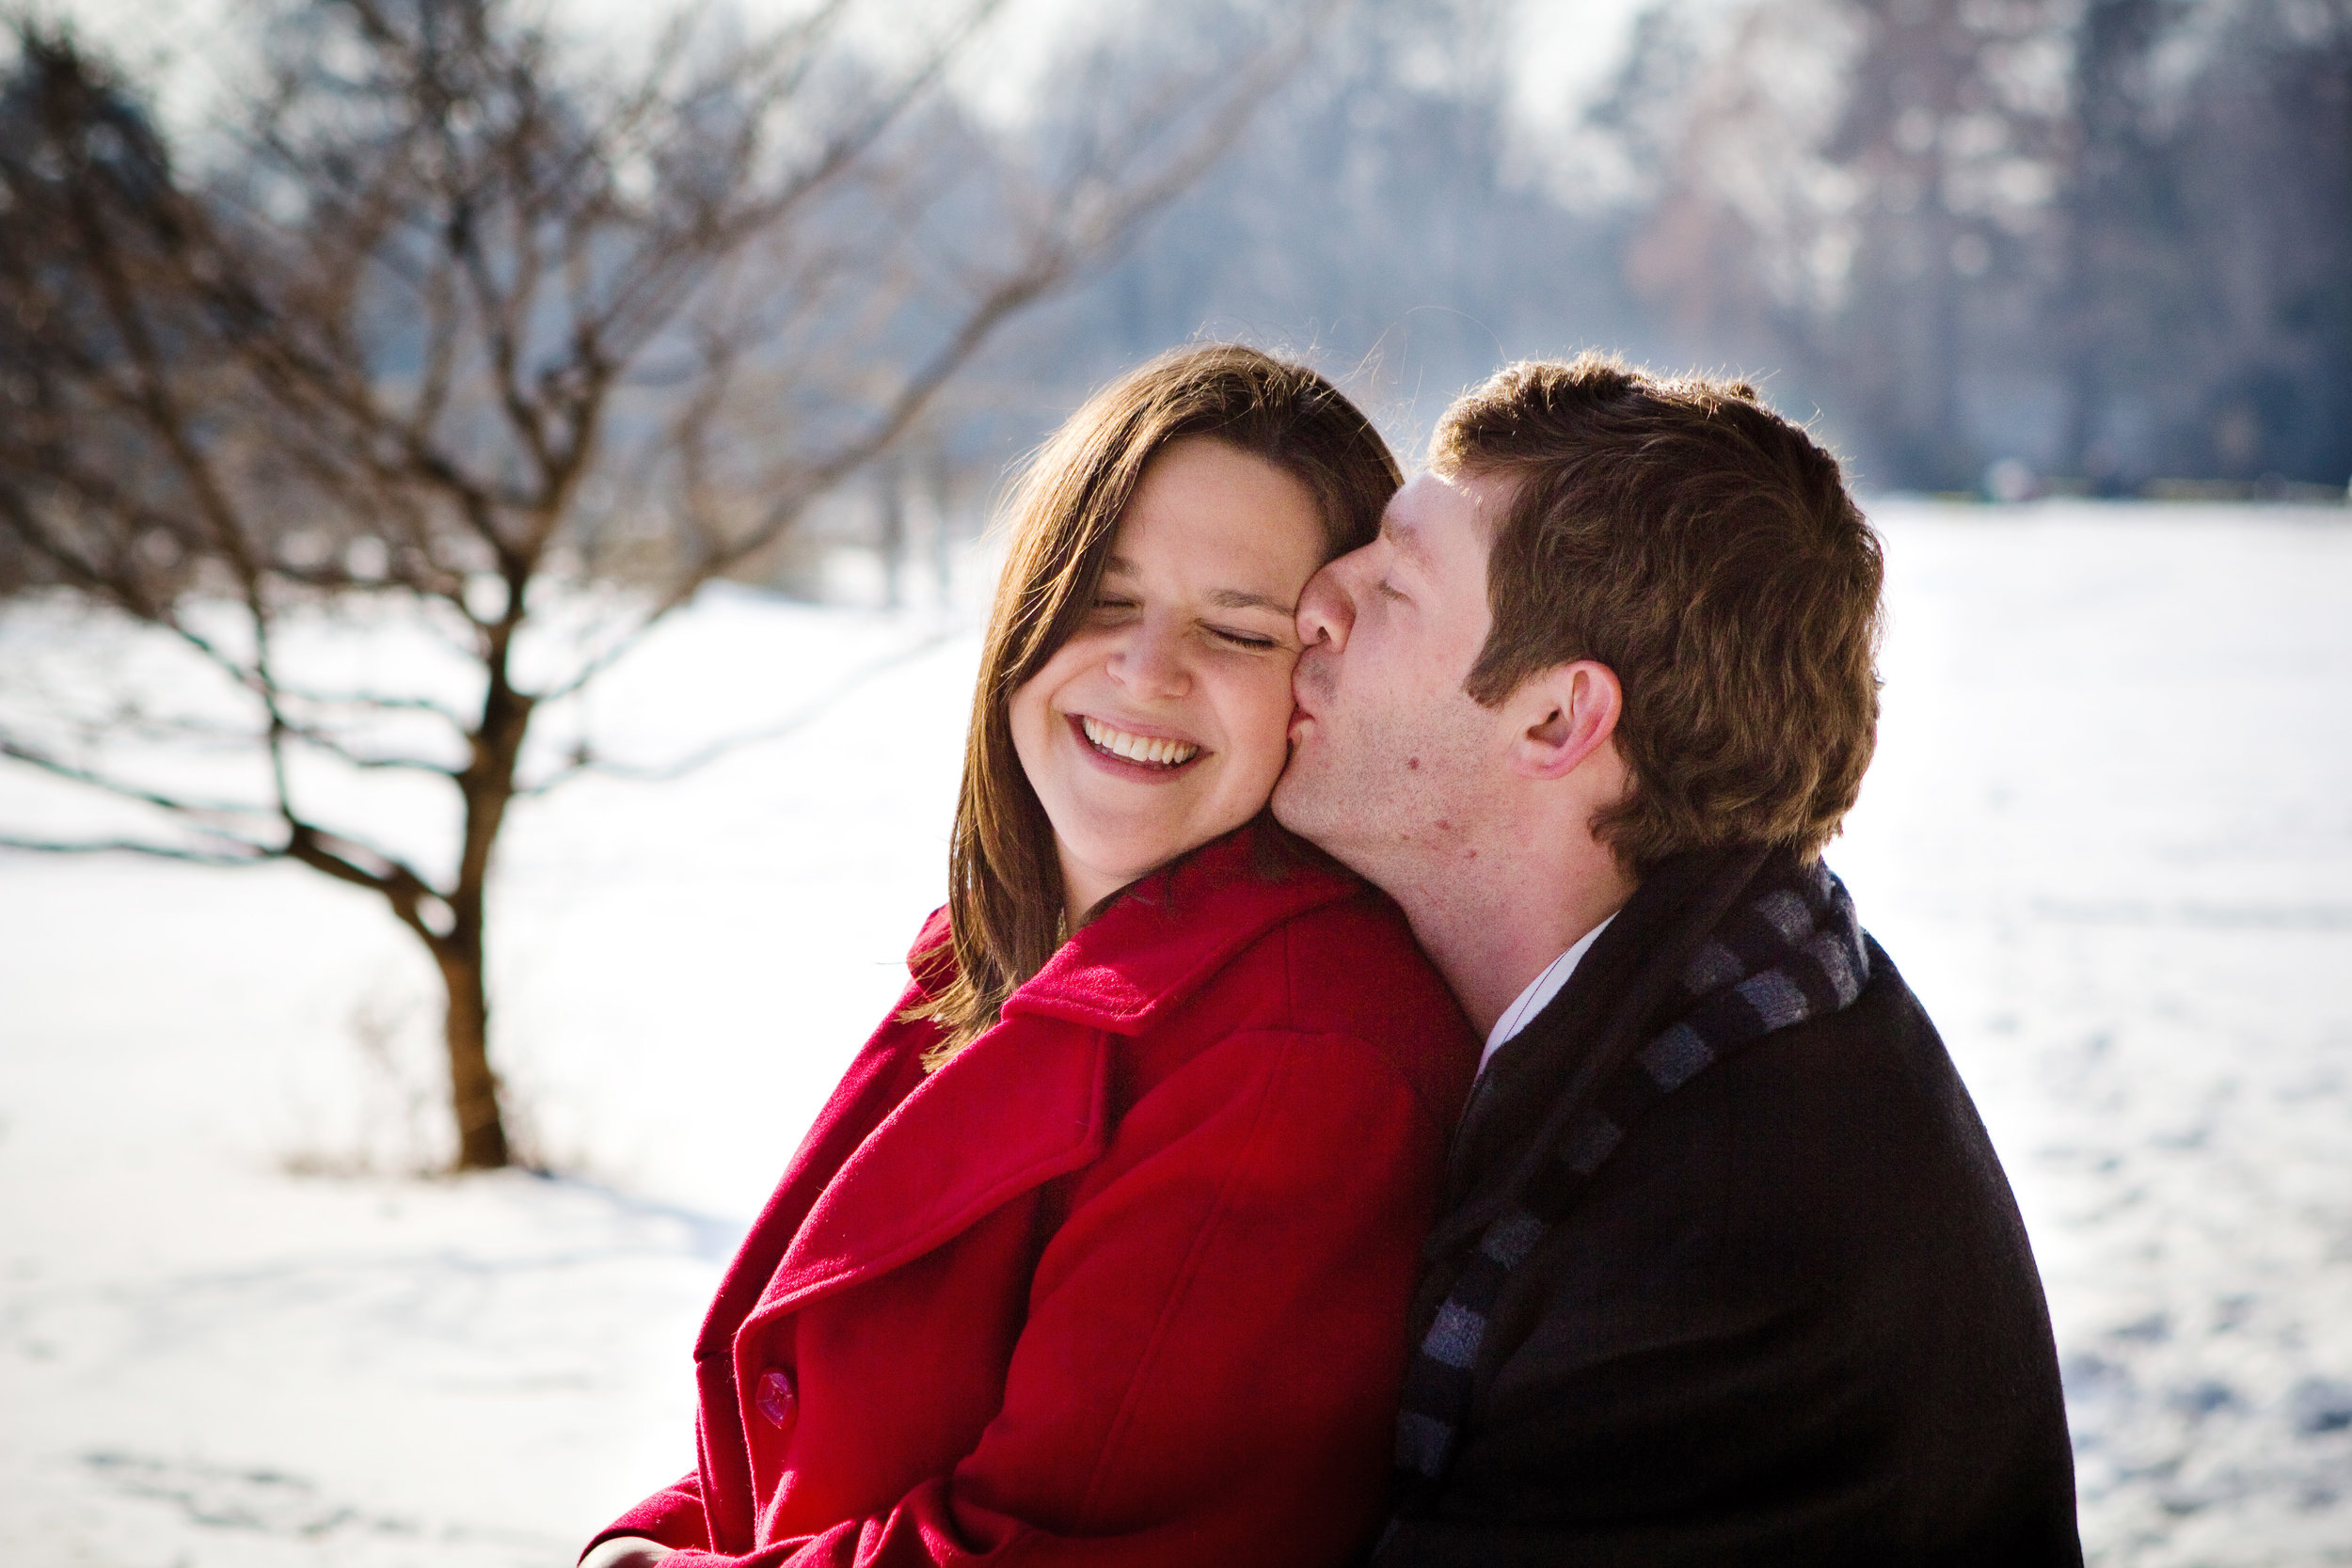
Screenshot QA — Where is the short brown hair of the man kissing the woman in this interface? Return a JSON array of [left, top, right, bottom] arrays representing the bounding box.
[[1430, 355, 1884, 870]]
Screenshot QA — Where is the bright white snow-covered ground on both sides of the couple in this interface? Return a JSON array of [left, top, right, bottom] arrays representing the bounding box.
[[0, 503, 2352, 1568]]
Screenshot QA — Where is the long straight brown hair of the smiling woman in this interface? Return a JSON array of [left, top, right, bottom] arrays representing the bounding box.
[[911, 343, 1402, 1068]]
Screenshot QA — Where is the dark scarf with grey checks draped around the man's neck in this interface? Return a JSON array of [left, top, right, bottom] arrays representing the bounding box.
[[1397, 853, 1870, 1502]]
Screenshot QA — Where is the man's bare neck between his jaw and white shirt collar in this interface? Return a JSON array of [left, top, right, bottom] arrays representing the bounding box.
[[1388, 842, 1637, 1035]]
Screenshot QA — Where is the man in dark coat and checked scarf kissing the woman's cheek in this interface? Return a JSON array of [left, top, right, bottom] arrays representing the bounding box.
[[1275, 355, 2082, 1568]]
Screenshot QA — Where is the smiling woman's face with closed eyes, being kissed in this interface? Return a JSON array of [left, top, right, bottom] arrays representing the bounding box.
[[1009, 435, 1325, 914]]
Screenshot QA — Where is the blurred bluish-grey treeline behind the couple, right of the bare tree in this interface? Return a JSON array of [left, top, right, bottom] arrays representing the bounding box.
[[991, 0, 2352, 499]]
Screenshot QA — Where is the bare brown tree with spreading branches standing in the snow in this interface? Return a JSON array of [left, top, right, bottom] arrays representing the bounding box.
[[0, 0, 1331, 1168]]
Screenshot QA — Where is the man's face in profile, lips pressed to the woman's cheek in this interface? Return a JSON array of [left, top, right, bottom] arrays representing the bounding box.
[[1275, 465, 1510, 891]]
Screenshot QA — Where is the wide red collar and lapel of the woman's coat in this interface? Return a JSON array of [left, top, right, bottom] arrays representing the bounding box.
[[734, 828, 1358, 1350]]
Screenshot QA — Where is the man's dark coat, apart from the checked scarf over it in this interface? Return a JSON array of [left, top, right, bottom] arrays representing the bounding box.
[[1376, 853, 2082, 1568]]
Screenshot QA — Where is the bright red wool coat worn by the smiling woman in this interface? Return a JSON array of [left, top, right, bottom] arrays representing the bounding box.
[[597, 830, 1477, 1568]]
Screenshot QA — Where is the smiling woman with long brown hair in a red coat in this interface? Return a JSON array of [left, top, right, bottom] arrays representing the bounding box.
[[583, 345, 1477, 1568]]
